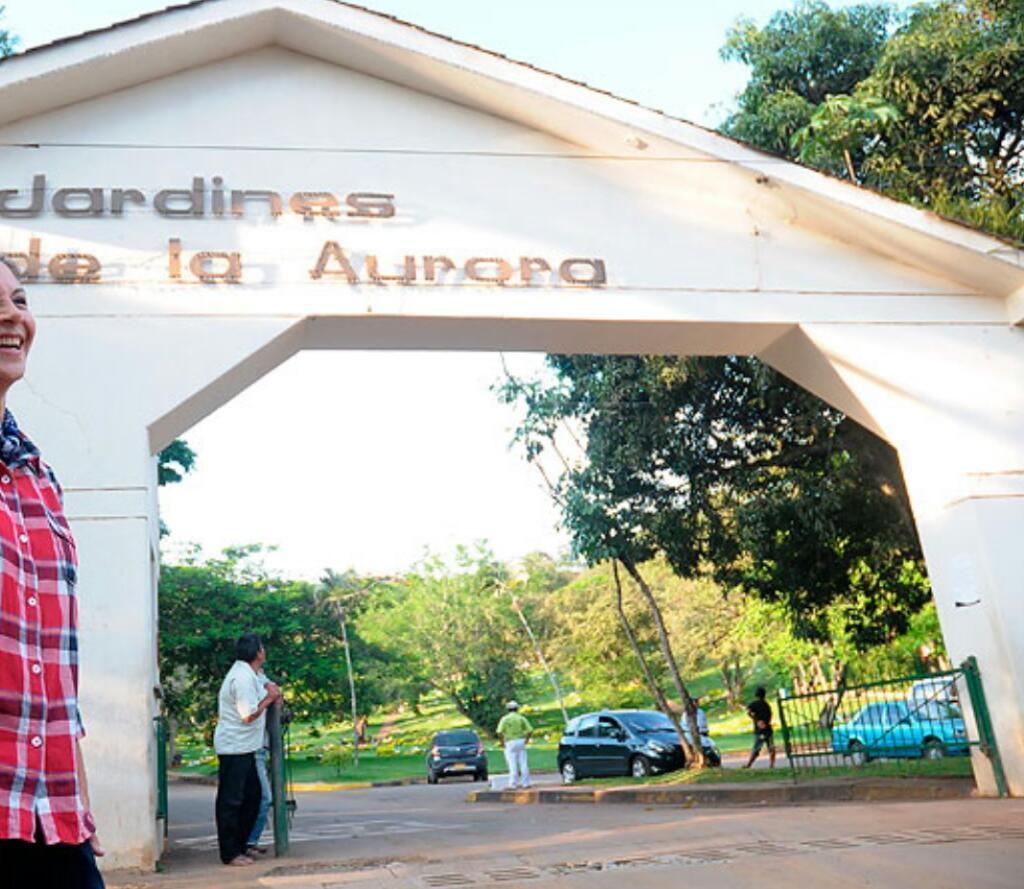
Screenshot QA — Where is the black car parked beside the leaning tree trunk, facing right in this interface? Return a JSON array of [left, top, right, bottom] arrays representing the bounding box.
[[558, 710, 721, 784]]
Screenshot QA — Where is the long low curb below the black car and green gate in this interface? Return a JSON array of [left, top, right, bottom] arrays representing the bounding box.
[[466, 778, 975, 808]]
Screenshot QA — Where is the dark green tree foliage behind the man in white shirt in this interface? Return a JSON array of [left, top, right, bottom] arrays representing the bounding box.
[[160, 547, 385, 731]]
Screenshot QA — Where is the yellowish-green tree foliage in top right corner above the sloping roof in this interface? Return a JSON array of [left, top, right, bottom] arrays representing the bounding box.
[[858, 0, 1024, 241]]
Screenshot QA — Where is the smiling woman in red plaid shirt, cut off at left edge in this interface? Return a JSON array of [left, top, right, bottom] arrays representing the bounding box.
[[0, 255, 103, 889]]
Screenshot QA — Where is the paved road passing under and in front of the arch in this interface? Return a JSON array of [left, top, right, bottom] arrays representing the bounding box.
[[111, 781, 1024, 889]]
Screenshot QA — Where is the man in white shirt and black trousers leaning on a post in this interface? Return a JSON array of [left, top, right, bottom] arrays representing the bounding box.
[[213, 633, 281, 867]]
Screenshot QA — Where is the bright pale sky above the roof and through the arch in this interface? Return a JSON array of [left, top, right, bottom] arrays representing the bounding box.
[[0, 0, 907, 578]]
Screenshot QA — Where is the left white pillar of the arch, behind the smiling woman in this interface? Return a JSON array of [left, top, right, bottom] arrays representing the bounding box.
[[10, 316, 303, 870]]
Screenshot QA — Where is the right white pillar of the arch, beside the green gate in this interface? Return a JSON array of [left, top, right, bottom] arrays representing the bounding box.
[[790, 325, 1024, 796]]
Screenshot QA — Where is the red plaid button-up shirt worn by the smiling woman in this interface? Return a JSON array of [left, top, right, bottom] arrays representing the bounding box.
[[0, 413, 95, 844]]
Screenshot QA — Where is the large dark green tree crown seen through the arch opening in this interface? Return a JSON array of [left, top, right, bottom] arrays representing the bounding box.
[[499, 355, 929, 646]]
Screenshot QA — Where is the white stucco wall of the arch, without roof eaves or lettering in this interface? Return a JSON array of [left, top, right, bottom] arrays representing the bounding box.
[[0, 39, 1024, 866]]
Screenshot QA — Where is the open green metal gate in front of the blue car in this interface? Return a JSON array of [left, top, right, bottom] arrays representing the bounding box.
[[778, 658, 1007, 797]]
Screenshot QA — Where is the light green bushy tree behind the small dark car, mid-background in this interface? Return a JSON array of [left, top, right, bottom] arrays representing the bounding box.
[[356, 547, 529, 734]]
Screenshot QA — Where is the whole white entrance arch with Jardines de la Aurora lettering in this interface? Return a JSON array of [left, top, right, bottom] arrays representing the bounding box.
[[0, 0, 1024, 866]]
